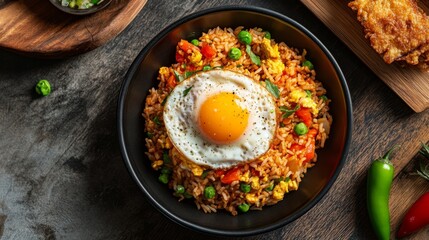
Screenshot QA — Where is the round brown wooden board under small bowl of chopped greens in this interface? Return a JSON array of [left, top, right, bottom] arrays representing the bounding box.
[[0, 0, 147, 58]]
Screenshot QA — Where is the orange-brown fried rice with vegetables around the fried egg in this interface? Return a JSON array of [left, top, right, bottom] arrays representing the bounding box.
[[142, 27, 332, 215]]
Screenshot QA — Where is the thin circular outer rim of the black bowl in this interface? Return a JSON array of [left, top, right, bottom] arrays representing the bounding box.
[[117, 5, 353, 237]]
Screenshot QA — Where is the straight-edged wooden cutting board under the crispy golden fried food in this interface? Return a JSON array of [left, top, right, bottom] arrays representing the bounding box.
[[301, 0, 429, 112]]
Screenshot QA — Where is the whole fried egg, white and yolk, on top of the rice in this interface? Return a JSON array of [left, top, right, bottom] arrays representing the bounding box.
[[163, 70, 277, 169]]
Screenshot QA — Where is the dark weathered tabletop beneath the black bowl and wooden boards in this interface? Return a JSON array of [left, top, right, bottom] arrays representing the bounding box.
[[0, 0, 429, 240]]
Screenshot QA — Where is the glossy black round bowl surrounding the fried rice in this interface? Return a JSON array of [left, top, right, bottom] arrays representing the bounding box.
[[118, 6, 352, 236]]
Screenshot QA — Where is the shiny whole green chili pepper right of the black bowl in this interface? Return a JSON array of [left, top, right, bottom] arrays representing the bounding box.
[[367, 147, 395, 240]]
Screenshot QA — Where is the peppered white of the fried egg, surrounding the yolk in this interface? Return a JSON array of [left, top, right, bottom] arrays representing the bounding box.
[[163, 70, 277, 169]]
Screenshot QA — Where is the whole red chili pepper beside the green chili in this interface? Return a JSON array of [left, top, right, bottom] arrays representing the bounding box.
[[396, 192, 429, 238]]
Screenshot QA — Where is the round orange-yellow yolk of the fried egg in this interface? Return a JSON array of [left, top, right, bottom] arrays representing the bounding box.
[[198, 92, 249, 144]]
